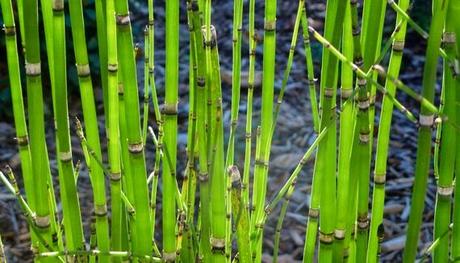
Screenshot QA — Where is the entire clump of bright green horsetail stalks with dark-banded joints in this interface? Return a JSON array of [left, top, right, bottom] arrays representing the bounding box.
[[0, 0, 460, 263]]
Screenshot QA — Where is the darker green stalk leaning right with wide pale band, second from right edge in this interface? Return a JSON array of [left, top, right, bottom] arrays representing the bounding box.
[[403, 0, 449, 262]]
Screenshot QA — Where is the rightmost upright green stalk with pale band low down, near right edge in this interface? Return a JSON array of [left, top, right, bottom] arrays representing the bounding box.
[[433, 4, 458, 262]]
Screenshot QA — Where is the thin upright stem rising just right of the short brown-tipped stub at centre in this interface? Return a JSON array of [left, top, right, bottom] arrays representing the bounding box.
[[242, 0, 257, 223]]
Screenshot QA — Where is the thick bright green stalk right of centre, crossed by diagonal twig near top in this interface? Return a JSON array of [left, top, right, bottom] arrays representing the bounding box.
[[310, 0, 347, 262]]
